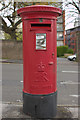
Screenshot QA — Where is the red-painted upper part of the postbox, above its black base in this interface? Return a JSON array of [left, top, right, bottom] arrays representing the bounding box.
[[17, 6, 61, 94]]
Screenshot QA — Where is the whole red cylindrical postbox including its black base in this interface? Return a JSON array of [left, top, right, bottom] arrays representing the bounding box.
[[17, 5, 61, 118]]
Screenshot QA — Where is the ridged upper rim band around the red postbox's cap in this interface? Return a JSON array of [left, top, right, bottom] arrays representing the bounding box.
[[17, 5, 62, 16]]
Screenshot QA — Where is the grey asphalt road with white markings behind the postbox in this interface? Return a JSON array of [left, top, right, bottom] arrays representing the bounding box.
[[2, 58, 80, 106]]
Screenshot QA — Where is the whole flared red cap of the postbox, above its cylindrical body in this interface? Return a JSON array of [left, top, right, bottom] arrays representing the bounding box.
[[17, 5, 62, 19]]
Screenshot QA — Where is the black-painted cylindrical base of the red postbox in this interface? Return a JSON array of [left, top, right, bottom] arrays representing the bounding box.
[[23, 92, 57, 119]]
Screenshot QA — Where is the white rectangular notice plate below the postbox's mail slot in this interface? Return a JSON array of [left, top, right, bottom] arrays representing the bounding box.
[[36, 33, 46, 50]]
